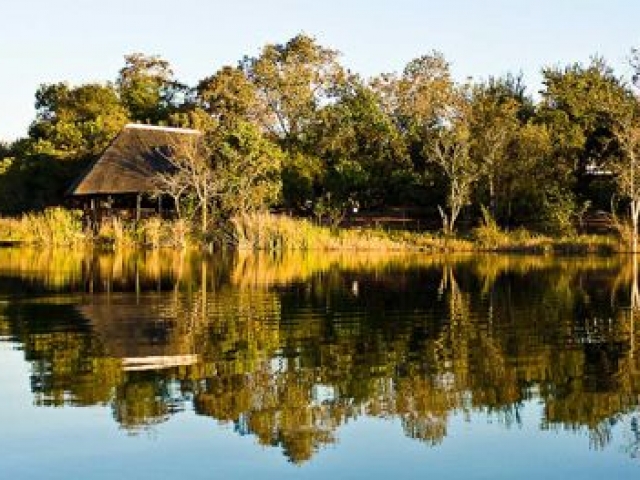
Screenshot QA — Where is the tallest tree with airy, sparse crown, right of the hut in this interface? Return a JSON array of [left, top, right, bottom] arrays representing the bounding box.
[[240, 34, 345, 209]]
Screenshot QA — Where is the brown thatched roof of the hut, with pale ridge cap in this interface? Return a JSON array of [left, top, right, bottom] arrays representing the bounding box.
[[69, 124, 199, 195]]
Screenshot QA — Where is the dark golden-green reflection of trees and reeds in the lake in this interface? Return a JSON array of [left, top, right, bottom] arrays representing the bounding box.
[[0, 249, 640, 462]]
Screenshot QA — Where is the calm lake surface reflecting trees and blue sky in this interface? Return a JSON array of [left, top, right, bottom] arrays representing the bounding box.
[[0, 248, 640, 479]]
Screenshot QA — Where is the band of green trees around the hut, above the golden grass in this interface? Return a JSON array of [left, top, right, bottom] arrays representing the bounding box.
[[0, 35, 640, 233]]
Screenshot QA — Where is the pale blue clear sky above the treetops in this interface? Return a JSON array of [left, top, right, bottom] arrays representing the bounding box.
[[0, 0, 640, 141]]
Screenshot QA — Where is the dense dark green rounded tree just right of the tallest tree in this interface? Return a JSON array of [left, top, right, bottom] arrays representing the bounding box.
[[310, 76, 409, 224]]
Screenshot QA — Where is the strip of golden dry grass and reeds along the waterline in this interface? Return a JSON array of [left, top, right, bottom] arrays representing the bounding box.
[[0, 208, 628, 254]]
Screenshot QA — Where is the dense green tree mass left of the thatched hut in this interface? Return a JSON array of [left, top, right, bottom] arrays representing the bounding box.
[[0, 83, 128, 214]]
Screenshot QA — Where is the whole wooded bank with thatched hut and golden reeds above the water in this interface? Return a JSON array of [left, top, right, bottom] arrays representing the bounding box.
[[0, 35, 640, 253]]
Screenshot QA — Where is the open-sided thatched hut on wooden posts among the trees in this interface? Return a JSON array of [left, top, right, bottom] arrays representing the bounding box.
[[68, 124, 199, 223]]
